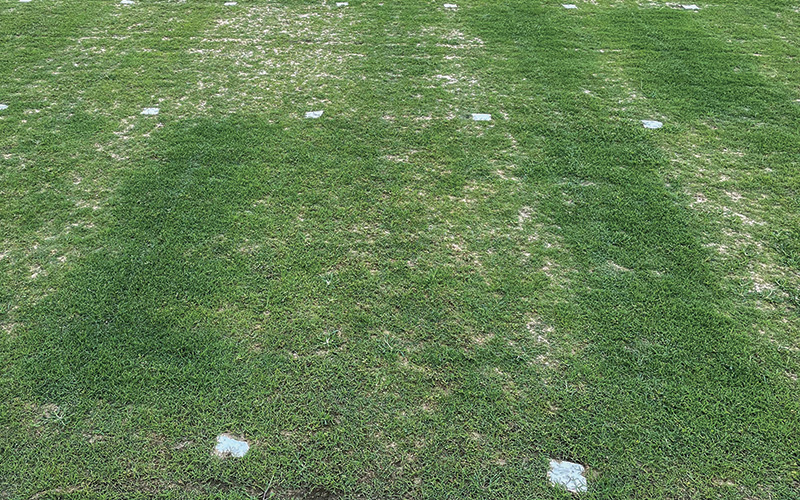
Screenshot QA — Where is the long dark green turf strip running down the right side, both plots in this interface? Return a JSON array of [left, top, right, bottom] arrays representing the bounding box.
[[462, 0, 798, 498]]
